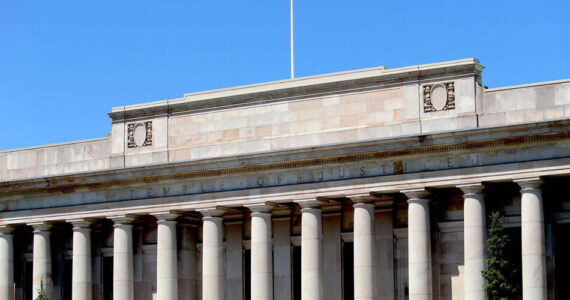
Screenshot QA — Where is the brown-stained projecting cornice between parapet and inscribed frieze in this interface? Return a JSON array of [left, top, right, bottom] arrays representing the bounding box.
[[0, 120, 570, 196]]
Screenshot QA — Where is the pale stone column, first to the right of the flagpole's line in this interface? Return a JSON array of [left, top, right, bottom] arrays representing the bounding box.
[[300, 201, 325, 300]]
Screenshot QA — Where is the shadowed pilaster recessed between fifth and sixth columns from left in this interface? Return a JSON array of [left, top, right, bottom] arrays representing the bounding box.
[[178, 221, 198, 300]]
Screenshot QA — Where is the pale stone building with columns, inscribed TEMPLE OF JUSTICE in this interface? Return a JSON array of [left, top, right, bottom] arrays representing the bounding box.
[[0, 59, 570, 300]]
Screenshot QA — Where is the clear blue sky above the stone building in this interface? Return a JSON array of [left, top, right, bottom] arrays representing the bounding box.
[[0, 0, 570, 150]]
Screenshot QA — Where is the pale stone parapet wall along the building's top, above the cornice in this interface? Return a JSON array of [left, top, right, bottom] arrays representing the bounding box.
[[0, 59, 570, 181]]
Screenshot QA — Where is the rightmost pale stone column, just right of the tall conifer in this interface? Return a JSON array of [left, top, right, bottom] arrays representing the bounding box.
[[517, 178, 546, 300]]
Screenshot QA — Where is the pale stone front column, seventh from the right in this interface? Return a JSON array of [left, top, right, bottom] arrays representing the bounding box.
[[201, 209, 225, 300]]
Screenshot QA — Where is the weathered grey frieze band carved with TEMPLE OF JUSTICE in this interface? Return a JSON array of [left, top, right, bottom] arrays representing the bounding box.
[[2, 132, 570, 201]]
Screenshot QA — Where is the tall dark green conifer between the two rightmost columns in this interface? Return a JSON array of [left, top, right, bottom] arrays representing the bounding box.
[[481, 212, 518, 300]]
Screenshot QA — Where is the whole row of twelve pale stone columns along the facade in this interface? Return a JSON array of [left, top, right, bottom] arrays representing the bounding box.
[[0, 179, 546, 300]]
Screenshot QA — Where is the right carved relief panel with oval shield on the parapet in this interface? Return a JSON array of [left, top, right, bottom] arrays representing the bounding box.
[[424, 81, 455, 113]]
